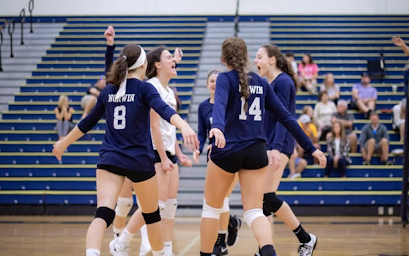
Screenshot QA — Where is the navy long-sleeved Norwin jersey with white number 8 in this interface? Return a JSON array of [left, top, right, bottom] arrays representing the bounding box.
[[78, 79, 176, 171]]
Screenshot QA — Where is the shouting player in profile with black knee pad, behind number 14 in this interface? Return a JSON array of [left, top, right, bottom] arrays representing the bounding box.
[[254, 45, 317, 256]]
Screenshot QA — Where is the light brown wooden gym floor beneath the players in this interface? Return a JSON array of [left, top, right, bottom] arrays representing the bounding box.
[[0, 216, 409, 256]]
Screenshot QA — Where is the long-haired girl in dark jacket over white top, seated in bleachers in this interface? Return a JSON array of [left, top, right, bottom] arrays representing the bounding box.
[[324, 122, 351, 178]]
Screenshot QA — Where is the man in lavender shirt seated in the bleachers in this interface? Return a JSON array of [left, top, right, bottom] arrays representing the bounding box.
[[351, 72, 378, 118]]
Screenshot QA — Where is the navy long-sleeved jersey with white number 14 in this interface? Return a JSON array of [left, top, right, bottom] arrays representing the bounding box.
[[211, 70, 315, 159]]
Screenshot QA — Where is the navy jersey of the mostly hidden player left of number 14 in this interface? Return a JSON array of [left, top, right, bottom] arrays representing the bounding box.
[[197, 98, 213, 153]]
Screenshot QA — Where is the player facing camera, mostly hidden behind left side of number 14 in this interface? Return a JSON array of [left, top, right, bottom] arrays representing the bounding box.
[[193, 70, 241, 256]]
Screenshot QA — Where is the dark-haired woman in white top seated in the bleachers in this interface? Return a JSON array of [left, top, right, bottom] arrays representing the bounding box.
[[314, 91, 337, 140]]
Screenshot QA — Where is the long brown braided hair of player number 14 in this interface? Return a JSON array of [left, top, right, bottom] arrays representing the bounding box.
[[221, 37, 250, 112]]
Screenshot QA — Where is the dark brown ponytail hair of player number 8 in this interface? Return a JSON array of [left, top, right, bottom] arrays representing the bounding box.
[[107, 44, 141, 86]]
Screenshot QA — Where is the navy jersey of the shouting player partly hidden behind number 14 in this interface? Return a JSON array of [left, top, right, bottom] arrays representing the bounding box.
[[265, 72, 295, 155]]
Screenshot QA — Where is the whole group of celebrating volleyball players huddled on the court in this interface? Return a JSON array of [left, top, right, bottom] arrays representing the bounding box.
[[53, 27, 326, 256]]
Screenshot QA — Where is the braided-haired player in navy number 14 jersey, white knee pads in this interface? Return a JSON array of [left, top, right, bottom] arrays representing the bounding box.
[[200, 38, 326, 256]]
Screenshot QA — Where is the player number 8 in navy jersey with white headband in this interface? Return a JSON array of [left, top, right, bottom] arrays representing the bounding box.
[[53, 45, 199, 256]]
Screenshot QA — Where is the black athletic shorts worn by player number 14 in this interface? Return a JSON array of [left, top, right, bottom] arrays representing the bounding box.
[[212, 141, 268, 173]]
